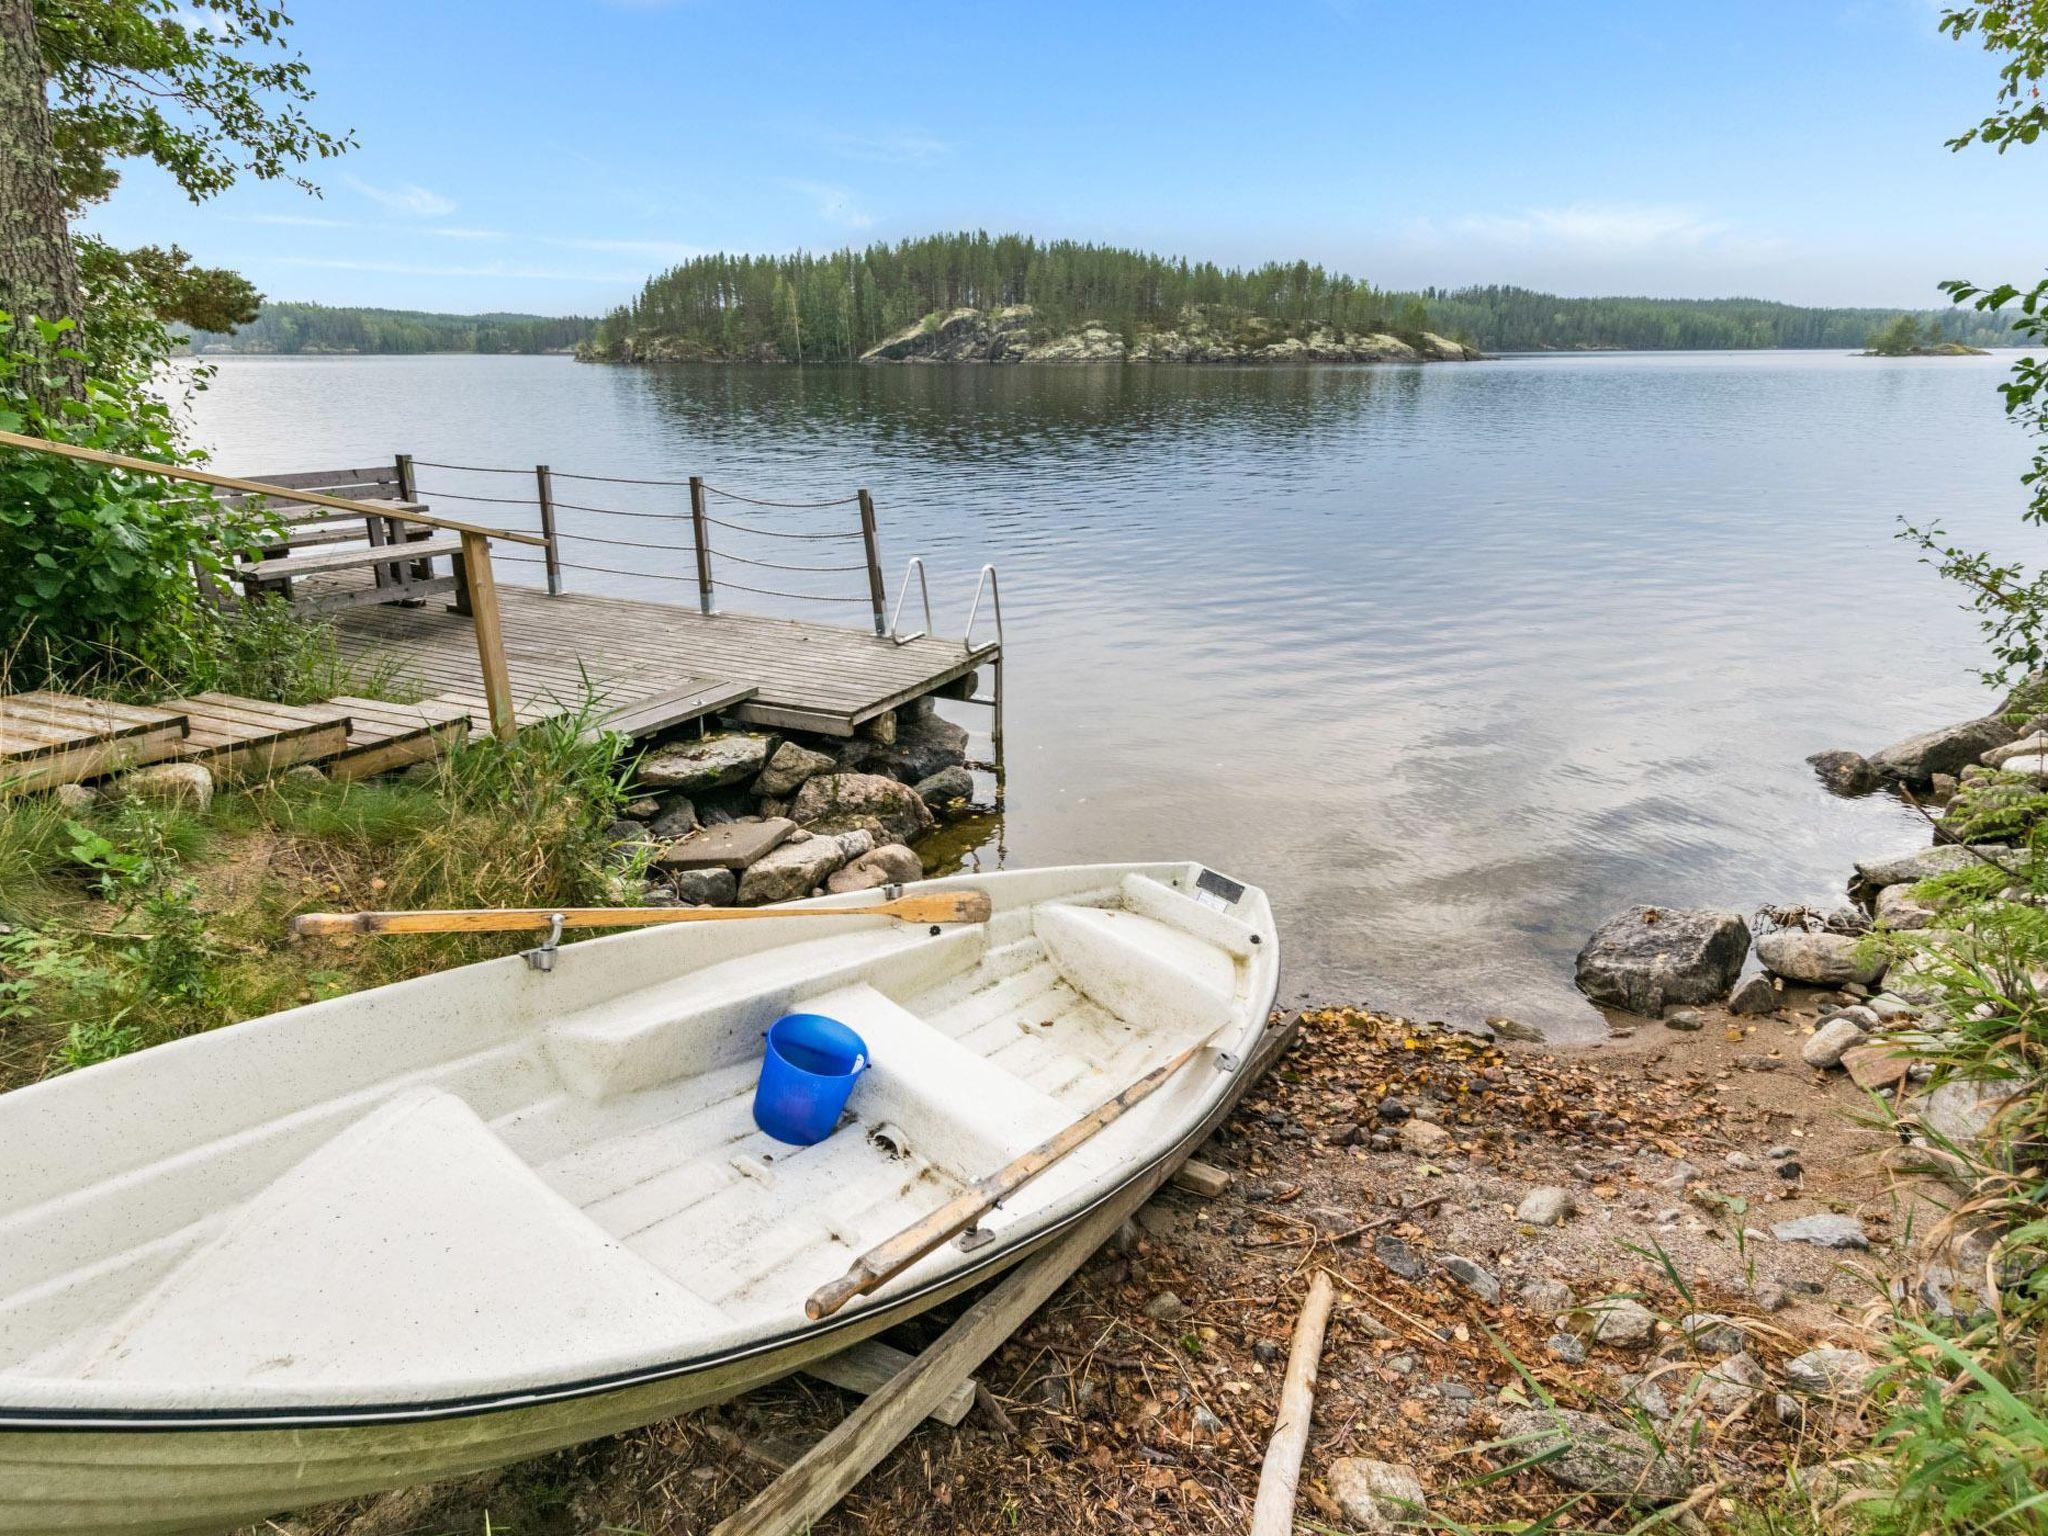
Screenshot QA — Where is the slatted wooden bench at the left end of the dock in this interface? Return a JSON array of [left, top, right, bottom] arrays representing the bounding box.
[[219, 463, 461, 612]]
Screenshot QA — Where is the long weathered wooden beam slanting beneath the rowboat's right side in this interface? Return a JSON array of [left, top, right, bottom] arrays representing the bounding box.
[[711, 1014, 1300, 1536]]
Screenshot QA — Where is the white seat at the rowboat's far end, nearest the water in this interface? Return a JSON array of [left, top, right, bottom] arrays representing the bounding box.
[[1032, 889, 1239, 1038]]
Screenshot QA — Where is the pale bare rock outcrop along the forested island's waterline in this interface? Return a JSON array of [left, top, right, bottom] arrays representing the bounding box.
[[860, 303, 1479, 362]]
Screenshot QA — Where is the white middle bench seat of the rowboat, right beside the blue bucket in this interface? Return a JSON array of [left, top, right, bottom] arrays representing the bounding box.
[[805, 985, 1073, 1180]]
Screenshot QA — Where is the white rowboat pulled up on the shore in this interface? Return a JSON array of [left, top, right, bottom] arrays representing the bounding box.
[[0, 864, 1280, 1536]]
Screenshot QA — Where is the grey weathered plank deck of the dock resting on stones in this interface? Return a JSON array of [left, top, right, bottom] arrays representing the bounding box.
[[334, 586, 1001, 735]]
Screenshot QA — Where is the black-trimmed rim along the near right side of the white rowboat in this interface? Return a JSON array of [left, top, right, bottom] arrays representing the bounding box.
[[0, 932, 1280, 1434]]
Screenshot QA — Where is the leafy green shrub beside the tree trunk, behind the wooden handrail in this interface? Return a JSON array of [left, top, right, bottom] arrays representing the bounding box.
[[0, 311, 264, 688]]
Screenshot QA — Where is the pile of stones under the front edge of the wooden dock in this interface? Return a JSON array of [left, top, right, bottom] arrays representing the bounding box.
[[593, 696, 987, 907]]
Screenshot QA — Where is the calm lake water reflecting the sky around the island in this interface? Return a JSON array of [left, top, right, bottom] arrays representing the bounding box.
[[195, 352, 2028, 1034]]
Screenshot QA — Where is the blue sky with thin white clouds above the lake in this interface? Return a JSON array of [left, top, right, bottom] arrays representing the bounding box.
[[75, 0, 2048, 313]]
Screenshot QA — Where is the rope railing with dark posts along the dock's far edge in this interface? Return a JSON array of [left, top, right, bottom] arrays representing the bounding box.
[[399, 457, 889, 635]]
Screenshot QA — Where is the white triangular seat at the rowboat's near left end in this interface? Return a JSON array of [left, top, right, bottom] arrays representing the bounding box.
[[78, 1087, 727, 1397]]
